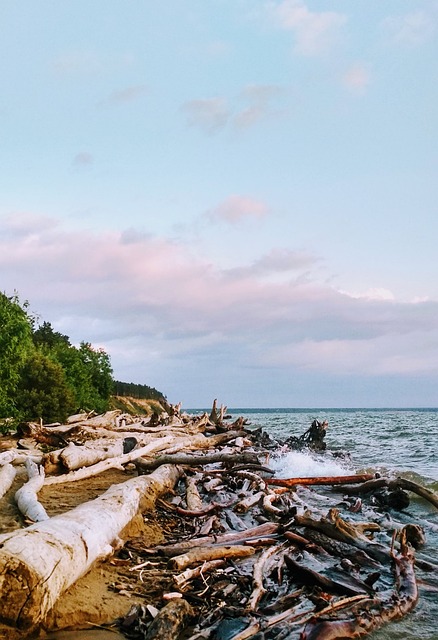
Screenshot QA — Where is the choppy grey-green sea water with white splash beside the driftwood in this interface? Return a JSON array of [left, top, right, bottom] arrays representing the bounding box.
[[230, 409, 438, 640]]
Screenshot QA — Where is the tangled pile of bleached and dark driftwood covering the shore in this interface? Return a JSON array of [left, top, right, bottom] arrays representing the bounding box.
[[0, 401, 438, 640]]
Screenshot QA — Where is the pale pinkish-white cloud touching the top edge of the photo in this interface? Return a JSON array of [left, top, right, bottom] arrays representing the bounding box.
[[267, 0, 347, 56]]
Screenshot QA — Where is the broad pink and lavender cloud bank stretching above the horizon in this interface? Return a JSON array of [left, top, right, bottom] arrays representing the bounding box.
[[0, 215, 438, 384]]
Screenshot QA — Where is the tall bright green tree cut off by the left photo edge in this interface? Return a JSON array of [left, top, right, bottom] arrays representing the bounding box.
[[0, 293, 35, 417]]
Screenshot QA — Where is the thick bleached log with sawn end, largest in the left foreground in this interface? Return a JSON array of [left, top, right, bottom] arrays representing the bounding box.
[[0, 465, 180, 629]]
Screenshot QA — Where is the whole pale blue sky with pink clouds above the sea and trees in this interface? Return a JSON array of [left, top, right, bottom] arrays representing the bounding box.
[[0, 0, 438, 408]]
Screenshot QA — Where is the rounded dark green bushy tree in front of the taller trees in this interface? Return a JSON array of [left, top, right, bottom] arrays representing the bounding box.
[[17, 351, 75, 422]]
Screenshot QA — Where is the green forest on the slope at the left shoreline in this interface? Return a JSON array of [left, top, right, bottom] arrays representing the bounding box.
[[0, 292, 165, 423]]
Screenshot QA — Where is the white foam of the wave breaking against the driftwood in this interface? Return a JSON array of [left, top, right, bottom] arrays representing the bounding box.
[[269, 451, 354, 478]]
